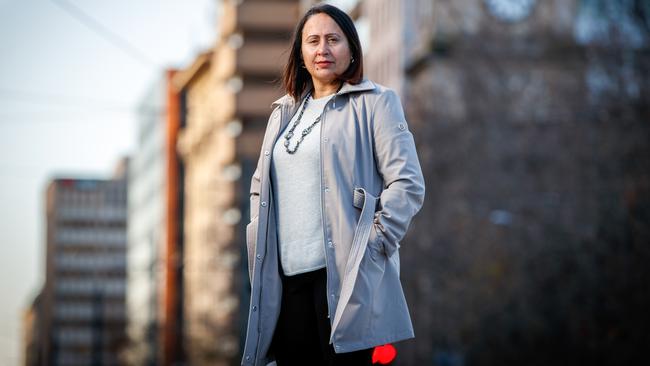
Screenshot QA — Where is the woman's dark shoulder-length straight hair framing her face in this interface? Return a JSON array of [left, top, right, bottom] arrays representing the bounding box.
[[282, 4, 363, 100]]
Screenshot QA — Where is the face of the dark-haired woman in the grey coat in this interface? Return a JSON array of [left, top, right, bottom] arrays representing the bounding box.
[[301, 13, 352, 88]]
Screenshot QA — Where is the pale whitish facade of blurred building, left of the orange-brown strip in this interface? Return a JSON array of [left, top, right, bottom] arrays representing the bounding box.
[[123, 73, 172, 365]]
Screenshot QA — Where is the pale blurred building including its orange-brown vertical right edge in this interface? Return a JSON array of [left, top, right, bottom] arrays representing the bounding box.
[[124, 71, 183, 365]]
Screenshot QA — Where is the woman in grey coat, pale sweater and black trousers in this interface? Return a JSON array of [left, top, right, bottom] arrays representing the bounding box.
[[242, 5, 424, 366]]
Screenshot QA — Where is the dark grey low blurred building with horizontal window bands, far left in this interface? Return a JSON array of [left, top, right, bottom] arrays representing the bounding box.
[[40, 161, 127, 366]]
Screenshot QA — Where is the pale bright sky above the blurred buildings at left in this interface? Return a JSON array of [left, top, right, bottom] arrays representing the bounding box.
[[0, 0, 354, 366]]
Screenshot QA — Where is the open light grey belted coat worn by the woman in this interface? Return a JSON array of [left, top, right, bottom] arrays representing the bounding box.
[[242, 80, 424, 365]]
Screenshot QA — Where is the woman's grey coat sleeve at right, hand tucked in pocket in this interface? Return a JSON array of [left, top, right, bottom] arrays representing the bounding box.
[[370, 89, 425, 257]]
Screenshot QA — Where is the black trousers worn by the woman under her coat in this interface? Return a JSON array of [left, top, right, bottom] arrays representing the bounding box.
[[271, 268, 373, 366]]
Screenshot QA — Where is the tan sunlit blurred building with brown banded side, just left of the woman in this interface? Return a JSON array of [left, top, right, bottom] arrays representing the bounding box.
[[174, 0, 299, 365]]
